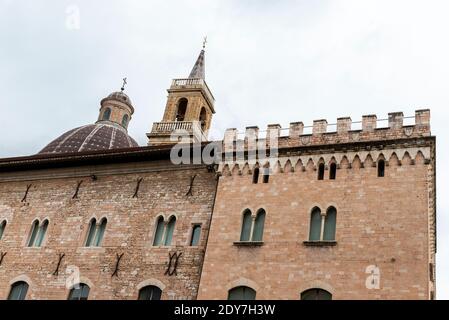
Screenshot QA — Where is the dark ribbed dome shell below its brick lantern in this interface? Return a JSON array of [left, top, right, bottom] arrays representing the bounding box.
[[39, 122, 139, 154]]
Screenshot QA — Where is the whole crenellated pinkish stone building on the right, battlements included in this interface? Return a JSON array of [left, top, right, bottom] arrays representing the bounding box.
[[198, 110, 435, 299]]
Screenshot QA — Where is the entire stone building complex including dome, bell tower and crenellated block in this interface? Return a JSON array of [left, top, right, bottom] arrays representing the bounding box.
[[0, 50, 436, 299]]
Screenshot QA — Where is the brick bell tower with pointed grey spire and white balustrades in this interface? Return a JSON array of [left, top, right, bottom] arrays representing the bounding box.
[[147, 41, 215, 146]]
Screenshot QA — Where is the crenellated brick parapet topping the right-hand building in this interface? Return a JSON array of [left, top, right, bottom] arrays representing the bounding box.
[[223, 109, 431, 152]]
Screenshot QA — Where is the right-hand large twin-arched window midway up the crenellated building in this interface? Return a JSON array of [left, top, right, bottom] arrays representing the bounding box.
[[309, 207, 337, 241]]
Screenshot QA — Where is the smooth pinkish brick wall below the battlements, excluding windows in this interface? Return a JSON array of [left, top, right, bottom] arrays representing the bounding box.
[[198, 147, 430, 299]]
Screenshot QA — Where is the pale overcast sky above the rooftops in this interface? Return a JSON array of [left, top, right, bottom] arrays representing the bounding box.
[[0, 0, 449, 299]]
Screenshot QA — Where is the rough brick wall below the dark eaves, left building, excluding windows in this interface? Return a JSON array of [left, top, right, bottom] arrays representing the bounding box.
[[0, 162, 216, 299]]
